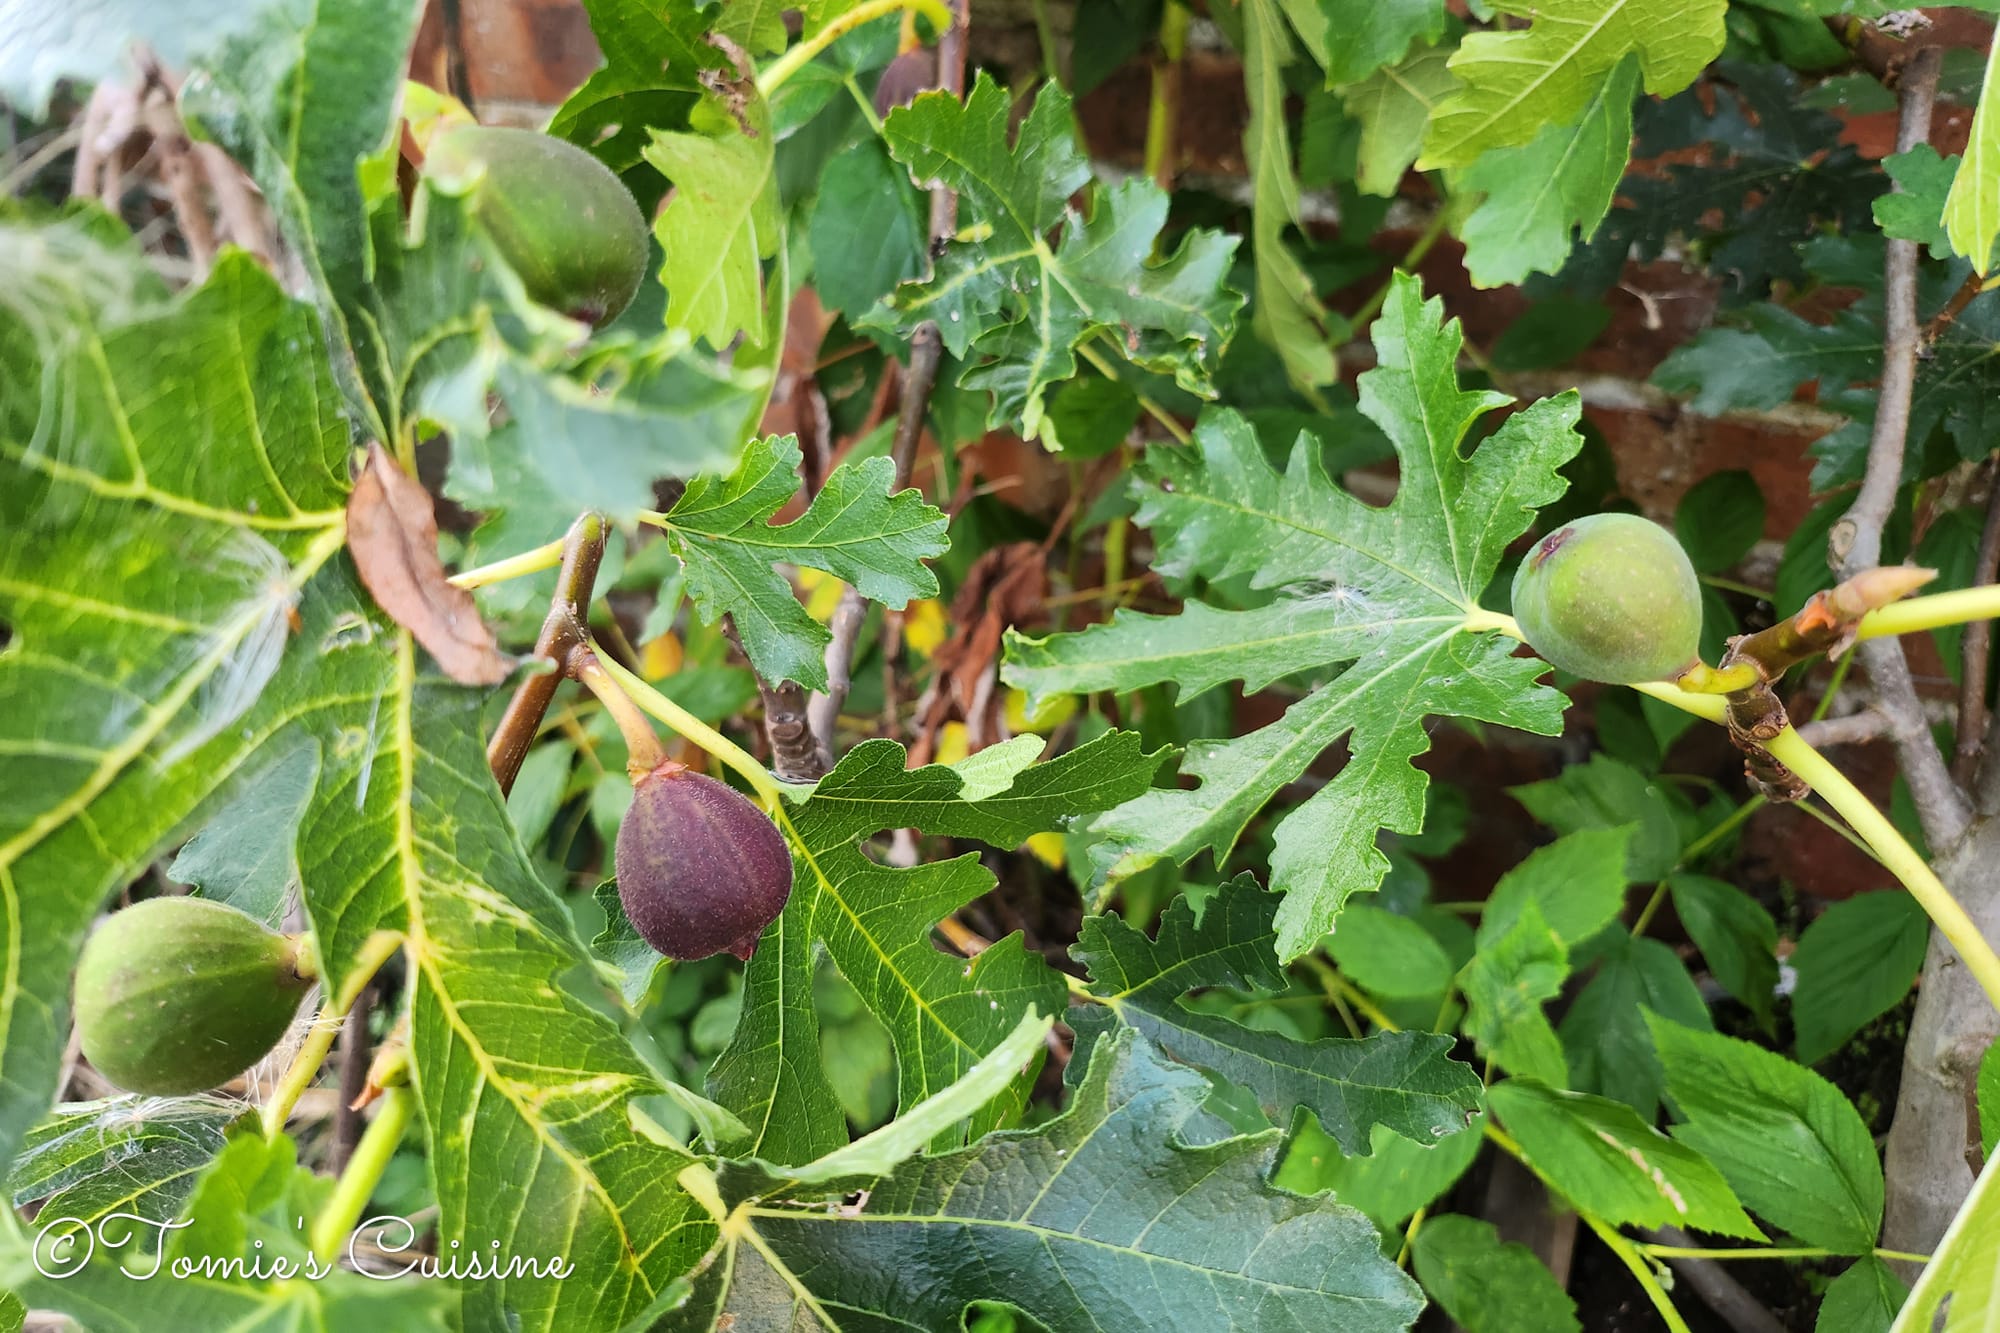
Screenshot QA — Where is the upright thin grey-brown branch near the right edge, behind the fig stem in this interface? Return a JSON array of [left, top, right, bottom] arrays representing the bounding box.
[[1828, 46, 1972, 849]]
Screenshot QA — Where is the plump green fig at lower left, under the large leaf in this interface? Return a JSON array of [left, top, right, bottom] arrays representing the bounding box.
[[76, 899, 314, 1097]]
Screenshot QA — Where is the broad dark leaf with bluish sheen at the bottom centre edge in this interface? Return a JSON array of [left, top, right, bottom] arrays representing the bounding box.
[[668, 1033, 1420, 1333]]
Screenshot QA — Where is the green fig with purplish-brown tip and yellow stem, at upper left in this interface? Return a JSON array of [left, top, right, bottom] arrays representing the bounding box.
[[424, 124, 646, 324]]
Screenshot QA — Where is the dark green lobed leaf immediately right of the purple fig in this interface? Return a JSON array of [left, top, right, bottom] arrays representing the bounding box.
[[710, 733, 1160, 1163]]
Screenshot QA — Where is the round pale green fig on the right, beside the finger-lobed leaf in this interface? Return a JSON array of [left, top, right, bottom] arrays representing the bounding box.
[[1514, 514, 1702, 685]]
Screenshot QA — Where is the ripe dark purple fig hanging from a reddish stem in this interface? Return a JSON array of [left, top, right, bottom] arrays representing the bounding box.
[[614, 761, 792, 961]]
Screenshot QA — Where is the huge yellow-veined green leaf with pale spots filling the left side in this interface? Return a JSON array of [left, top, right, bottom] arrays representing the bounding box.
[[0, 224, 712, 1329]]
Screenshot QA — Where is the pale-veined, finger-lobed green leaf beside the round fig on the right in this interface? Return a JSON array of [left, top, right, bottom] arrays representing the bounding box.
[[1002, 276, 1580, 959]]
